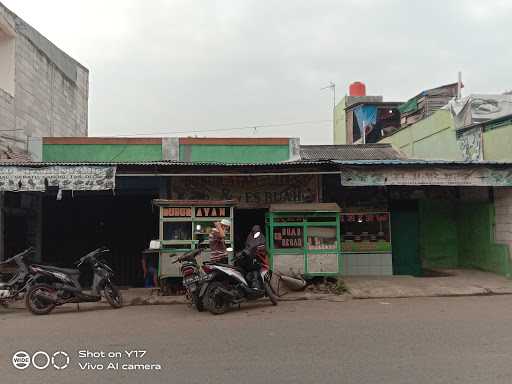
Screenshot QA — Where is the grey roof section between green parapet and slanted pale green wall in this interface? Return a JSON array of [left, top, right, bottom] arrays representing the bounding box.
[[300, 144, 405, 160]]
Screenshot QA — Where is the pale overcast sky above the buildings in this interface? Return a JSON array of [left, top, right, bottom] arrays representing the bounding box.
[[1, 0, 512, 144]]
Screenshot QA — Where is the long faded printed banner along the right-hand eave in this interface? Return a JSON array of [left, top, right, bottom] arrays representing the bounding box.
[[341, 167, 512, 187]]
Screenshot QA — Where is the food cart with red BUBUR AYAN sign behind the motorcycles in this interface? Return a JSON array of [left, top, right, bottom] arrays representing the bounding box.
[[153, 199, 235, 290]]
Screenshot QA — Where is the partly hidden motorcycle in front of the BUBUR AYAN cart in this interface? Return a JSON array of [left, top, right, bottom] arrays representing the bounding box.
[[171, 249, 205, 312]]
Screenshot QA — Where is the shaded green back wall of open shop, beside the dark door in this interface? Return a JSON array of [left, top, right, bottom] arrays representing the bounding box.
[[419, 200, 459, 268]]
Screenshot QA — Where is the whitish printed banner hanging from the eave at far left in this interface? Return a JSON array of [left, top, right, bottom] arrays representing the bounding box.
[[0, 165, 116, 192]]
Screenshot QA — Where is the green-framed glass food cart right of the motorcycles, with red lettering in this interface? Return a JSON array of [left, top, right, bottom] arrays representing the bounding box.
[[266, 203, 343, 276]]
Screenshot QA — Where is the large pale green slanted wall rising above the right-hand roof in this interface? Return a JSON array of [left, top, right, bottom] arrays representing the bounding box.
[[380, 109, 462, 160]]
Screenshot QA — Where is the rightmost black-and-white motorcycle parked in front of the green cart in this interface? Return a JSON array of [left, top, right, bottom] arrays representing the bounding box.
[[199, 232, 278, 315]]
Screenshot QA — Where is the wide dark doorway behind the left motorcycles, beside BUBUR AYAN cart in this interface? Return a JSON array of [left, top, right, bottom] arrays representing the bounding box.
[[43, 193, 158, 286]]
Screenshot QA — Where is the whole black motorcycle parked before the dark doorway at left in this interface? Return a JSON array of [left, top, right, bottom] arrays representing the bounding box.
[[26, 247, 123, 315]]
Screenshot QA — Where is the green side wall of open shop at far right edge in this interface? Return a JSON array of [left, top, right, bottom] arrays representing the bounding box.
[[457, 203, 511, 277]]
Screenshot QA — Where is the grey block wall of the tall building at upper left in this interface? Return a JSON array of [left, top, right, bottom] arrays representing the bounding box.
[[0, 3, 89, 153]]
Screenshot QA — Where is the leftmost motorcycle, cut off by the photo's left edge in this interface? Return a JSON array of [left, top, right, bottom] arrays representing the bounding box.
[[0, 247, 34, 307]]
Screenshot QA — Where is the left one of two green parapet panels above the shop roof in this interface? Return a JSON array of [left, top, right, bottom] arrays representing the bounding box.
[[43, 144, 162, 162]]
